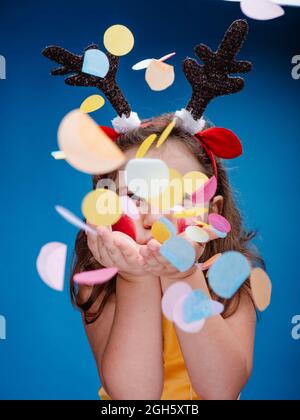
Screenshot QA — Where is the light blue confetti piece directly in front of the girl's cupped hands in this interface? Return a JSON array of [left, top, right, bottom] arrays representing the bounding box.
[[160, 237, 196, 273]]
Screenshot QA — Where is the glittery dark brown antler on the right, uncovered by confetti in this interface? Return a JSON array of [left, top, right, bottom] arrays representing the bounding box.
[[183, 20, 252, 121]]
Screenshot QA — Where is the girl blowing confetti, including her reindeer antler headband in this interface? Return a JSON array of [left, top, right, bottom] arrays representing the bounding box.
[[44, 20, 263, 400]]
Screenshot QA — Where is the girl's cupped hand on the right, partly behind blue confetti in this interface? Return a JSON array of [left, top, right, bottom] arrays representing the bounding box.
[[140, 233, 205, 280]]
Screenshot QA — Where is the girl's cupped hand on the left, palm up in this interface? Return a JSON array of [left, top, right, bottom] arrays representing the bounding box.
[[87, 227, 156, 282]]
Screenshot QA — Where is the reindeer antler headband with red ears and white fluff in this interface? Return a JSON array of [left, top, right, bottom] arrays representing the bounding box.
[[43, 20, 252, 176]]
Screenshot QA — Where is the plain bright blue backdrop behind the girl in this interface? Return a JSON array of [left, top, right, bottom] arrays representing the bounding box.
[[0, 0, 300, 399]]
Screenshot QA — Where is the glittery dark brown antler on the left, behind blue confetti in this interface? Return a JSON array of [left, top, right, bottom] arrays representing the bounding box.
[[42, 44, 131, 117]]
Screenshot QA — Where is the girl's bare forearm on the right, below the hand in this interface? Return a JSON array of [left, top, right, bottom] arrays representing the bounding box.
[[162, 270, 256, 400]]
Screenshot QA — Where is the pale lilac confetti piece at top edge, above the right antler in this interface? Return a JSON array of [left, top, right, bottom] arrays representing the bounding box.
[[241, 0, 285, 20]]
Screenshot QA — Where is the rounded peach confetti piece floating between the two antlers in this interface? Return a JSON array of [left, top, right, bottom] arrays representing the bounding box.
[[145, 60, 175, 92]]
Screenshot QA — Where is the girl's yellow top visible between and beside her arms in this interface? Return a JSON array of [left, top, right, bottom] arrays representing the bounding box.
[[99, 316, 200, 400]]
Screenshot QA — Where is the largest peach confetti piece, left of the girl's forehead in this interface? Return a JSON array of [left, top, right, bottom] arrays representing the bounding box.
[[58, 109, 126, 175]]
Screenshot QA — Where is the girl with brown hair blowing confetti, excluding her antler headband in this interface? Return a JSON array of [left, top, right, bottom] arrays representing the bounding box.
[[72, 115, 261, 400]]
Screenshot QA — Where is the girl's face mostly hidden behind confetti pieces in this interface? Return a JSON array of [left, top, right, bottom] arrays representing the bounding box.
[[116, 137, 222, 245]]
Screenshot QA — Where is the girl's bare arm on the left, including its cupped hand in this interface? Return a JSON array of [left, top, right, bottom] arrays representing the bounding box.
[[82, 230, 163, 400]]
